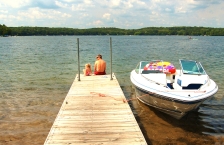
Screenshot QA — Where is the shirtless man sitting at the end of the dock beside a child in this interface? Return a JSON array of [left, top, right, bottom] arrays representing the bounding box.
[[94, 54, 106, 75]]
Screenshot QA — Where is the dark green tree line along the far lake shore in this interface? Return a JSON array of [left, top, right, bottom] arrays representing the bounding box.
[[0, 24, 224, 36]]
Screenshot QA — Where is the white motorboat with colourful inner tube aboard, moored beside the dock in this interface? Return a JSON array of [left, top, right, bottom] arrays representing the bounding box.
[[130, 59, 218, 119]]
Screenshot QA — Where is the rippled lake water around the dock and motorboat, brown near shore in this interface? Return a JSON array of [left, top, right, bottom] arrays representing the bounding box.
[[0, 36, 224, 145]]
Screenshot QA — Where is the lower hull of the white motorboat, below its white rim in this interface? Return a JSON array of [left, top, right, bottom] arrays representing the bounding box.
[[134, 85, 214, 119]]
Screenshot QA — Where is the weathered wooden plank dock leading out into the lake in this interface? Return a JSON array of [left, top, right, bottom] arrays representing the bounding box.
[[44, 74, 147, 145]]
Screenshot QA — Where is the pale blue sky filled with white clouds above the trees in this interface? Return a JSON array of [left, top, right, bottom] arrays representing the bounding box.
[[0, 0, 224, 29]]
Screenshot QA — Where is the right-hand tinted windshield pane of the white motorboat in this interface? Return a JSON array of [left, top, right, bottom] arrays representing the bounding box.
[[180, 60, 206, 75]]
